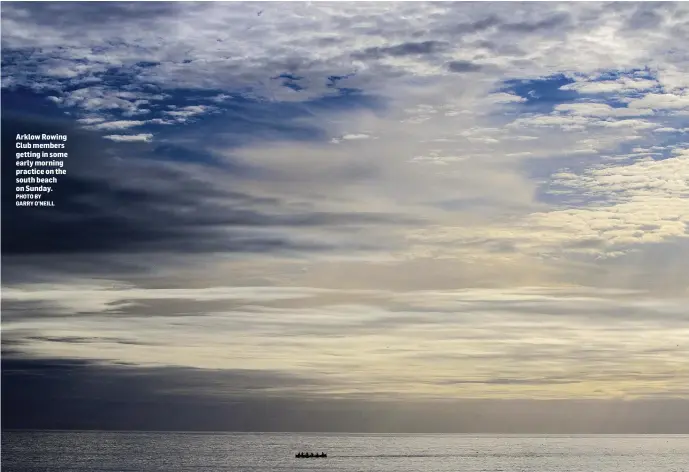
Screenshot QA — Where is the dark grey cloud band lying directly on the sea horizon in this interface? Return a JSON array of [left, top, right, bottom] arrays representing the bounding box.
[[2, 355, 689, 433]]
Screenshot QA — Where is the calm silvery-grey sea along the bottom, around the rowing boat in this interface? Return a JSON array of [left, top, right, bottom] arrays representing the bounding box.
[[1, 431, 689, 472]]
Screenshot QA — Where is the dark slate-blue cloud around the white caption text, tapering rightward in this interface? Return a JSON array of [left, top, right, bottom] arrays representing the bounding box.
[[3, 109, 414, 270]]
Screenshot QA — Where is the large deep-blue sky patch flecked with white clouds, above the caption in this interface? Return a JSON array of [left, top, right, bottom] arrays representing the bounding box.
[[2, 52, 382, 176]]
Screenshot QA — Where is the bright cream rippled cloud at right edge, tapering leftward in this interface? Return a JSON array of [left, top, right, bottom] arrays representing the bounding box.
[[404, 149, 689, 272]]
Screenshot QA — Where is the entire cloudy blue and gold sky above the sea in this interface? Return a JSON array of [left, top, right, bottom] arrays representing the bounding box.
[[1, 2, 689, 433]]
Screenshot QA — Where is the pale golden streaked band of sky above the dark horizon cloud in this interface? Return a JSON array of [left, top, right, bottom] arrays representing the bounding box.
[[4, 285, 689, 399]]
